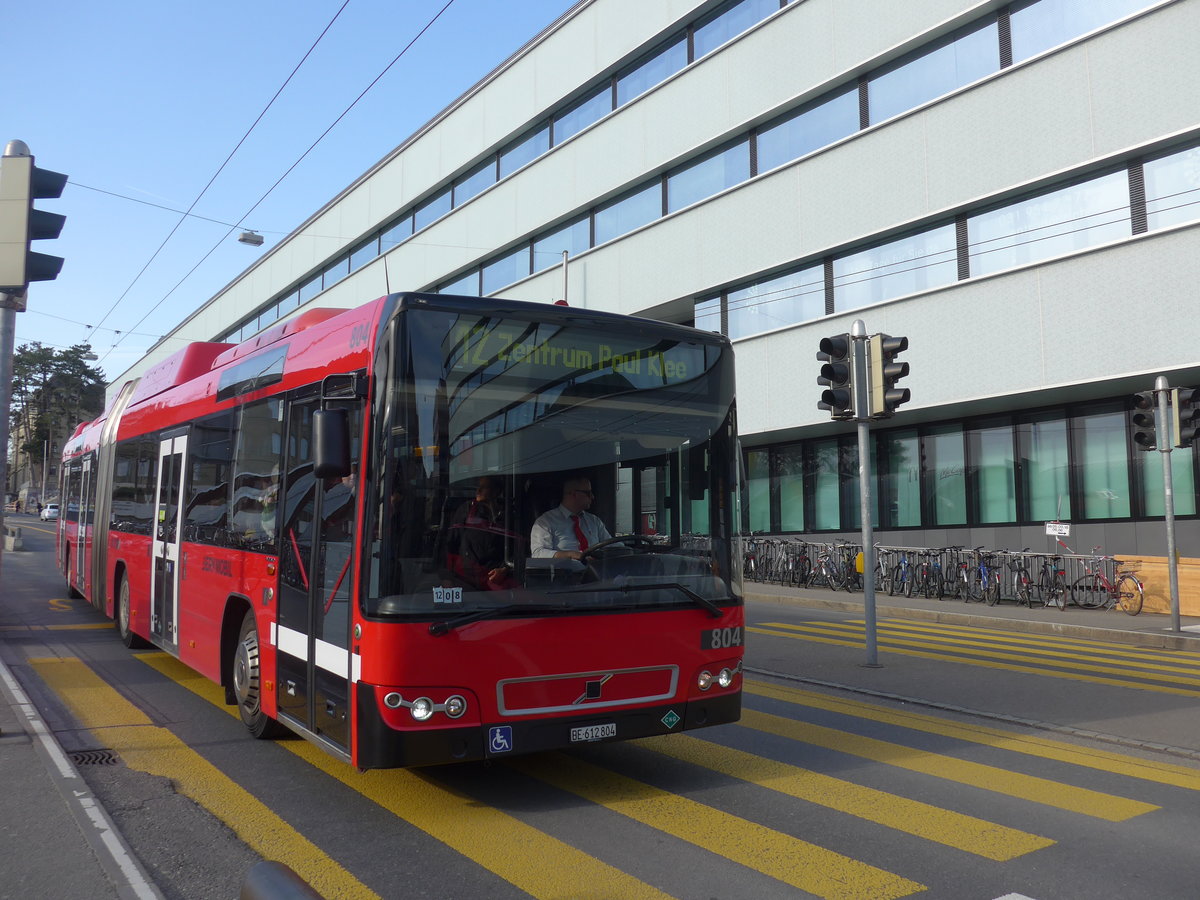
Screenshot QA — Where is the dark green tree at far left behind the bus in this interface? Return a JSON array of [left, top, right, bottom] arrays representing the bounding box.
[[10, 342, 106, 496]]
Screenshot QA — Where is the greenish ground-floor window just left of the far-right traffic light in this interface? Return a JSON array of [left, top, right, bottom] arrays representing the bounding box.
[[1072, 410, 1130, 518]]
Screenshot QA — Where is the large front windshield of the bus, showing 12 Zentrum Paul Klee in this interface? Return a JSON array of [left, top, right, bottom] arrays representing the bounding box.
[[362, 299, 742, 629]]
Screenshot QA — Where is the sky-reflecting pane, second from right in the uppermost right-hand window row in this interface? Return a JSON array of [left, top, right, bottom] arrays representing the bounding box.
[[868, 19, 1000, 125]]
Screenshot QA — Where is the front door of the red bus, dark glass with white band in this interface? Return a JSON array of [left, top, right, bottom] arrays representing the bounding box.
[[276, 398, 362, 749]]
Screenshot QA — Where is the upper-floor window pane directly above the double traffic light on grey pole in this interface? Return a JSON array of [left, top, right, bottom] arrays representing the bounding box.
[[833, 223, 959, 312]]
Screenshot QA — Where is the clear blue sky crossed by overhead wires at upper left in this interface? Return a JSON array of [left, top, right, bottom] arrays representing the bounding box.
[[0, 0, 574, 378]]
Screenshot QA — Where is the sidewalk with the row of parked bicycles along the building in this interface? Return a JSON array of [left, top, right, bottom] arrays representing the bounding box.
[[745, 581, 1200, 652]]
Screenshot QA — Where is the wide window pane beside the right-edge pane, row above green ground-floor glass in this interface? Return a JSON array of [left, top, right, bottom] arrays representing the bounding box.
[[967, 170, 1132, 276]]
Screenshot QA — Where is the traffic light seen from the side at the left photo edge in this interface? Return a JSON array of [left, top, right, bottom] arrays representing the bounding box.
[[0, 140, 67, 294]]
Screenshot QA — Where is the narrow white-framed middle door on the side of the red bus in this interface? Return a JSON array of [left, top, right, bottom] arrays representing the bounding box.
[[150, 434, 187, 647]]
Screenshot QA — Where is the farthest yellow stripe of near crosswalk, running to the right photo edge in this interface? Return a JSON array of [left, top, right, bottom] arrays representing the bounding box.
[[744, 680, 1200, 791]]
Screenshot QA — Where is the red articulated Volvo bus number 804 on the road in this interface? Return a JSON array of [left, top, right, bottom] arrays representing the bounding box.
[[58, 294, 744, 769]]
